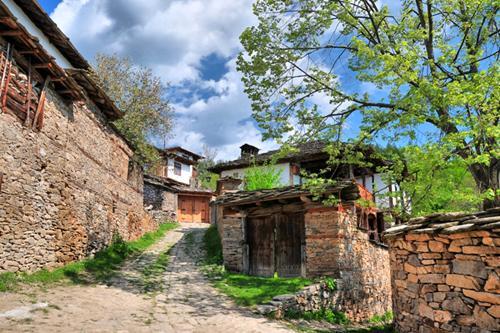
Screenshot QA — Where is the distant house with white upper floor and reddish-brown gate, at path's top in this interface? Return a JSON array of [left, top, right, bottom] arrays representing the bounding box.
[[144, 147, 213, 223]]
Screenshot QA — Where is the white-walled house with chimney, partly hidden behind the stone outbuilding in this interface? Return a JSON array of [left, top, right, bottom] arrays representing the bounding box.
[[209, 141, 409, 209]]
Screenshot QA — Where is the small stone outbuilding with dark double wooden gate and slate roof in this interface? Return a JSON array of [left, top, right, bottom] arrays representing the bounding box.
[[214, 181, 391, 320]]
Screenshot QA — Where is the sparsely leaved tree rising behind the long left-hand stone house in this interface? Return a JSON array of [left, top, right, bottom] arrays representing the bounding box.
[[93, 54, 173, 165]]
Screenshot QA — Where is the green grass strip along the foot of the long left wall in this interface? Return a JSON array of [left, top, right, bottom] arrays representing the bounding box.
[[0, 223, 178, 292]]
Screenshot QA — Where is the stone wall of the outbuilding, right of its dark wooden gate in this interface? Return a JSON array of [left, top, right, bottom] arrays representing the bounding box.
[[305, 208, 391, 321]]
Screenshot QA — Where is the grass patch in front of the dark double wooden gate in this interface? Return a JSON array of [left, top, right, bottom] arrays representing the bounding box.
[[203, 226, 312, 306]]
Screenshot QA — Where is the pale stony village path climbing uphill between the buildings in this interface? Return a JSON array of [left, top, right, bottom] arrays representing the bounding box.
[[0, 224, 290, 333]]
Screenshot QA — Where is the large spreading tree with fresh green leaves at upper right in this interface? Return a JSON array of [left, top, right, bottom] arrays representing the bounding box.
[[238, 0, 500, 207]]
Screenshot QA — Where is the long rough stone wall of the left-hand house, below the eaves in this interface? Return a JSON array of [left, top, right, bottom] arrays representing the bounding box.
[[0, 85, 157, 271]]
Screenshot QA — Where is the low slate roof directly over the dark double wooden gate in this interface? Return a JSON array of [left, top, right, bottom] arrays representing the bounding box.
[[214, 181, 359, 206]]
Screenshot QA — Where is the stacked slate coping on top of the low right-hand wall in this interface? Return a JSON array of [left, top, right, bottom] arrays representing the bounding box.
[[384, 207, 500, 239]]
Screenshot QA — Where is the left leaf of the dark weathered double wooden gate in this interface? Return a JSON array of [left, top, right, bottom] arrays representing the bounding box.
[[246, 216, 275, 276]]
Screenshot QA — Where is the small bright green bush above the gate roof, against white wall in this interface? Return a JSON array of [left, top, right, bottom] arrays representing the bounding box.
[[243, 163, 283, 191]]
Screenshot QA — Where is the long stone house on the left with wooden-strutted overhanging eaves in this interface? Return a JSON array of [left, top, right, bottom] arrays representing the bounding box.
[[0, 0, 157, 271]]
